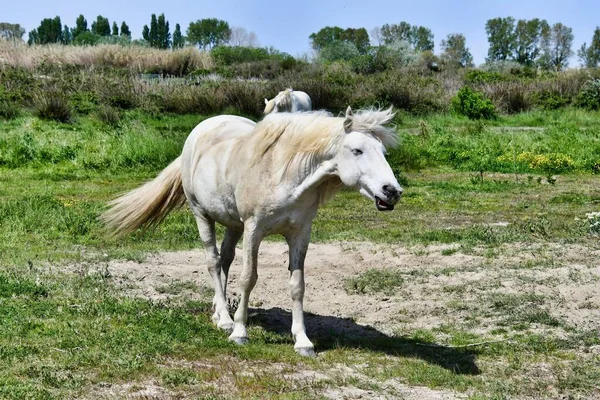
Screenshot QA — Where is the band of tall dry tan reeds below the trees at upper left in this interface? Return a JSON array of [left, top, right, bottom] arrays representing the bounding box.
[[0, 40, 213, 75]]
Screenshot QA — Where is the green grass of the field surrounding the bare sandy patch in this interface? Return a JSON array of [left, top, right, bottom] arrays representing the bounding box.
[[0, 110, 600, 399]]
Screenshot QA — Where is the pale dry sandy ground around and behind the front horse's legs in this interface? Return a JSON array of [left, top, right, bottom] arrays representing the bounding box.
[[82, 242, 600, 399]]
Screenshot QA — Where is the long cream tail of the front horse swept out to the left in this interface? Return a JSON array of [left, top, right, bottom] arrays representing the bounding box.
[[101, 157, 185, 236]]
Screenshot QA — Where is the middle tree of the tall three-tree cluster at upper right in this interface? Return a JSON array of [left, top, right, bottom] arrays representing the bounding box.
[[513, 18, 550, 67]]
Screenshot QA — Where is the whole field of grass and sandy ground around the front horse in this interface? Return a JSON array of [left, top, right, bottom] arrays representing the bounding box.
[[0, 104, 600, 399]]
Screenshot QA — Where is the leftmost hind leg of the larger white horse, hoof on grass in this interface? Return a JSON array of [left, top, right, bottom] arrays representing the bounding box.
[[195, 215, 233, 332]]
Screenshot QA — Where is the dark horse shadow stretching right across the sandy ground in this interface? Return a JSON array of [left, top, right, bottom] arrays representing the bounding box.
[[249, 307, 480, 375]]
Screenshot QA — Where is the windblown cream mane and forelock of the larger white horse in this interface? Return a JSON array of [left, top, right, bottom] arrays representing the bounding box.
[[250, 107, 398, 178]]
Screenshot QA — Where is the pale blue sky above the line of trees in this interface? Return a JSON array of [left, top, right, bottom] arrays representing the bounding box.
[[0, 0, 600, 65]]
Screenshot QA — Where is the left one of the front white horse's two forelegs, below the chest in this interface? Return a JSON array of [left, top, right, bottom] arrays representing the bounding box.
[[229, 221, 263, 344]]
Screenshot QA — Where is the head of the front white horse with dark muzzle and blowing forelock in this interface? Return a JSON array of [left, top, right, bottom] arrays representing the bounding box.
[[335, 107, 402, 211]]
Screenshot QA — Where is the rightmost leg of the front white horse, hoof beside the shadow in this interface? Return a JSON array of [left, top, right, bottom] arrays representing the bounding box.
[[286, 227, 315, 357]]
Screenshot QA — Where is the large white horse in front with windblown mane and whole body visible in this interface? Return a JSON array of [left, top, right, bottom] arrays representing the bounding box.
[[102, 107, 402, 356]]
